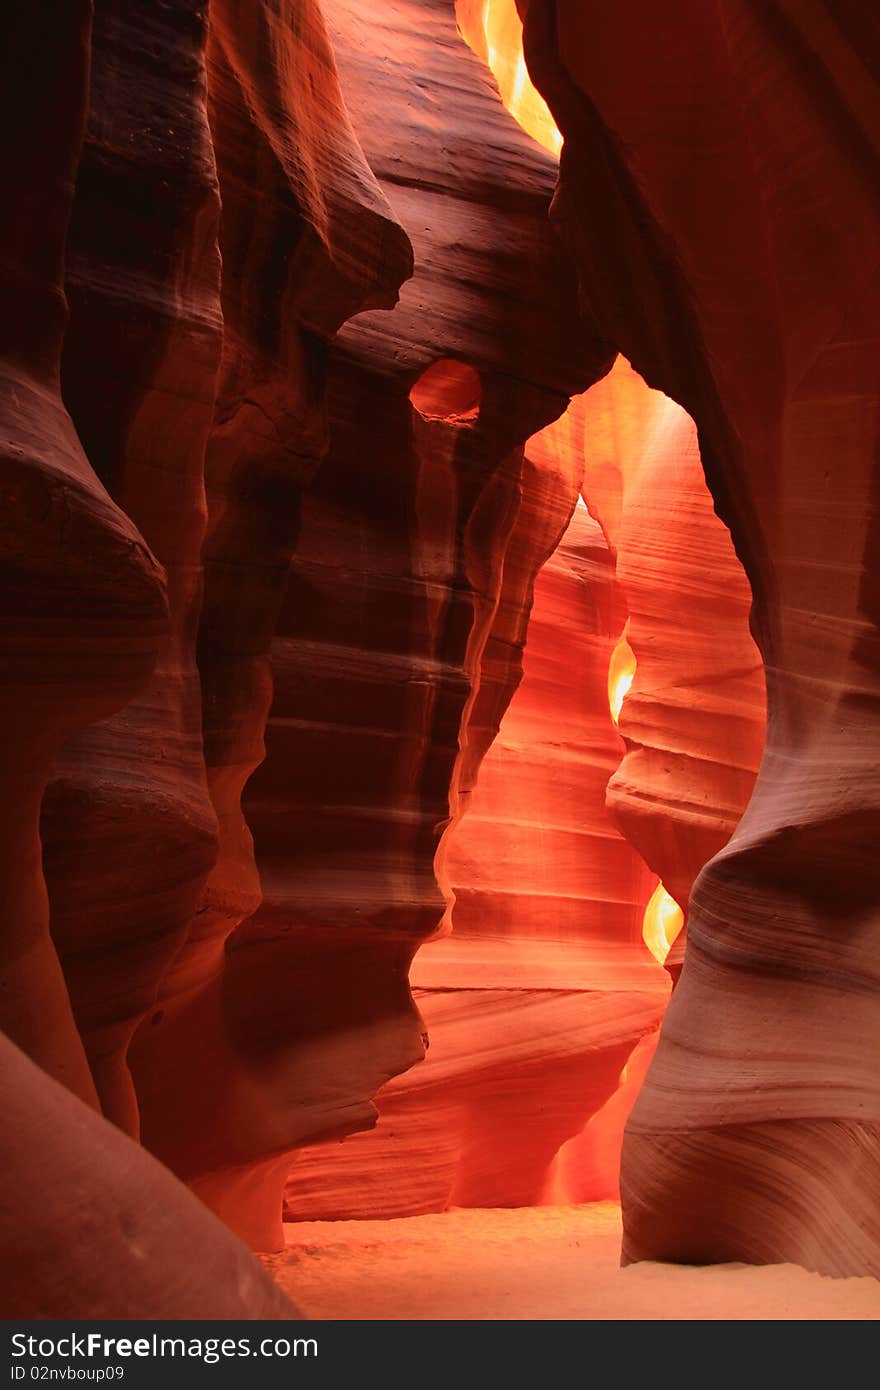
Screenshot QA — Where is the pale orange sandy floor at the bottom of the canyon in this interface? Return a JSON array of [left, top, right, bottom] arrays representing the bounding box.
[[266, 1202, 880, 1322]]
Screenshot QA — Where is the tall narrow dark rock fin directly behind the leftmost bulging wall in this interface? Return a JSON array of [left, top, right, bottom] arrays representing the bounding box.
[[42, 0, 221, 1134]]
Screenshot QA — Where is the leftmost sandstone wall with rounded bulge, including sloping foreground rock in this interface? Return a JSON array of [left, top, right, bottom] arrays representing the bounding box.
[[0, 4, 293, 1318]]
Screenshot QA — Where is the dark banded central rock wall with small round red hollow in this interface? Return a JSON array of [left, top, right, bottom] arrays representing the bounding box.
[[130, 3, 606, 1245]]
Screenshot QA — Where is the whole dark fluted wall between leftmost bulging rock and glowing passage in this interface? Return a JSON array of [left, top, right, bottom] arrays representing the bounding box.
[[8, 0, 625, 1273]]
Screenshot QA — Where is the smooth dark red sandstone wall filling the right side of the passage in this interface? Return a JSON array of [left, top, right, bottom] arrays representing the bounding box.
[[523, 0, 880, 1273]]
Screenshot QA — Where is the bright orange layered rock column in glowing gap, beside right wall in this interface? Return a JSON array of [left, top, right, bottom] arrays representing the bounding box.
[[577, 359, 765, 970]]
